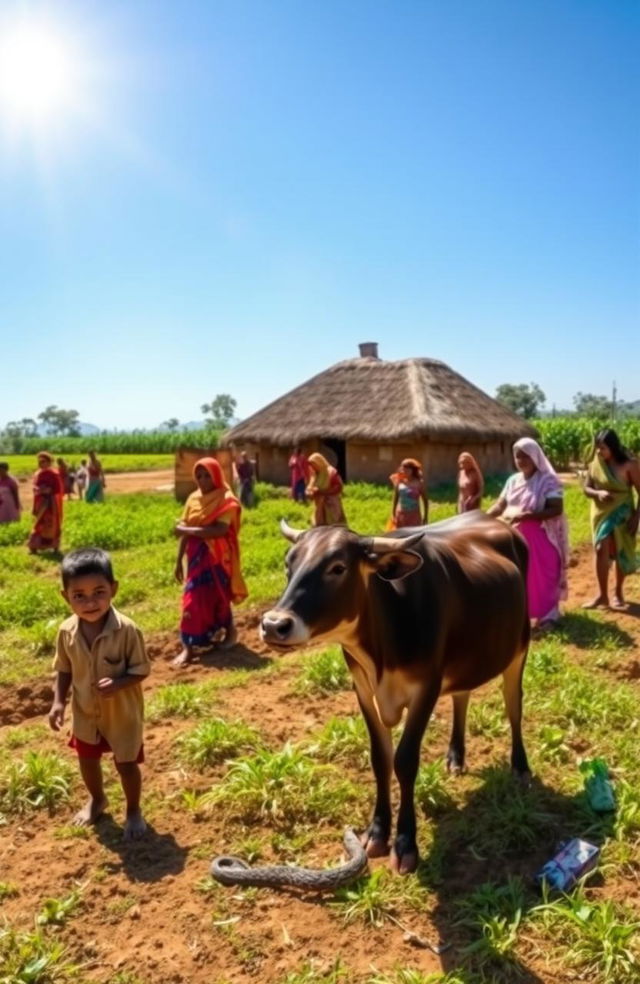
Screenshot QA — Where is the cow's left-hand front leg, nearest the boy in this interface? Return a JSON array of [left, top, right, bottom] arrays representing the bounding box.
[[350, 663, 393, 858]]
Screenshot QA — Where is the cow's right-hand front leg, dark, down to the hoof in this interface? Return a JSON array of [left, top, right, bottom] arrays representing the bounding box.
[[391, 680, 441, 875]]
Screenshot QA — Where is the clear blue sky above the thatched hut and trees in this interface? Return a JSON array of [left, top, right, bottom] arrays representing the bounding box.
[[0, 0, 640, 428]]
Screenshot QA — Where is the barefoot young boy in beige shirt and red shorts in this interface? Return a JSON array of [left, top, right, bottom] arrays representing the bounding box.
[[49, 547, 150, 840]]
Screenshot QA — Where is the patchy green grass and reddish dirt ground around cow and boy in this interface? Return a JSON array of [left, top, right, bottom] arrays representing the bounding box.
[[0, 484, 640, 984]]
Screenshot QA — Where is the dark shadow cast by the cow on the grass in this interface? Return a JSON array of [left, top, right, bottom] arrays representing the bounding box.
[[417, 767, 613, 984]]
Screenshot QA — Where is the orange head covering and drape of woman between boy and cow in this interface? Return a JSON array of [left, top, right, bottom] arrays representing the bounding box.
[[182, 458, 248, 602]]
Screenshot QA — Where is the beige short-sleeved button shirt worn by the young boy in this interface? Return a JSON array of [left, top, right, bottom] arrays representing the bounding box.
[[53, 606, 151, 762]]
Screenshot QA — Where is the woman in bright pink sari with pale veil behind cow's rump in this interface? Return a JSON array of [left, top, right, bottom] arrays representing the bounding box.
[[488, 437, 569, 629]]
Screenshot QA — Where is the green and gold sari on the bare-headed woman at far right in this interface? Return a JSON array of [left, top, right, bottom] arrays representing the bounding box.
[[589, 454, 638, 575]]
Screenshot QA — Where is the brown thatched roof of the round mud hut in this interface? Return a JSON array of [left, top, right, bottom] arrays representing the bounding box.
[[224, 357, 536, 447]]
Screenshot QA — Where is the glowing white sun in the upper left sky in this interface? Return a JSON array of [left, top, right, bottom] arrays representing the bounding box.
[[0, 22, 78, 126]]
